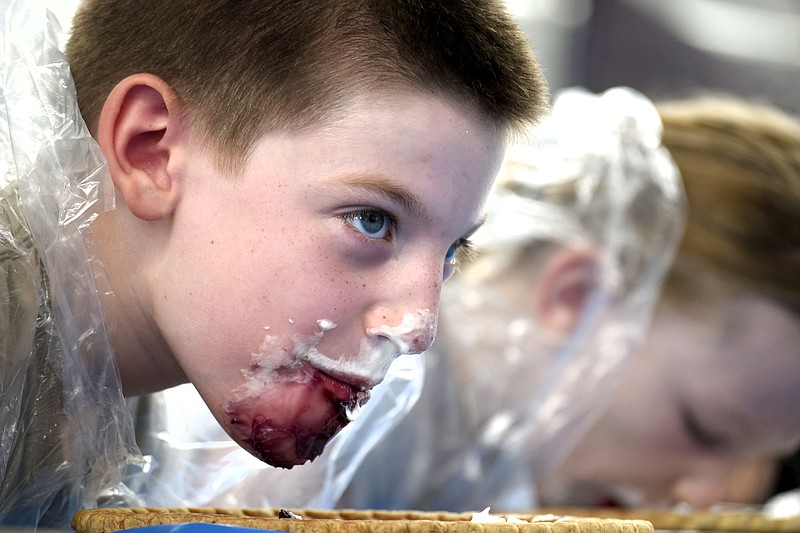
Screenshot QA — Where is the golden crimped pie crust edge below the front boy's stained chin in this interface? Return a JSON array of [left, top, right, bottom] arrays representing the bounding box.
[[72, 507, 653, 533]]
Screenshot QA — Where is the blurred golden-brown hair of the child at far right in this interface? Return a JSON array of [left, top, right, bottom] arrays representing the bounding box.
[[658, 96, 800, 311]]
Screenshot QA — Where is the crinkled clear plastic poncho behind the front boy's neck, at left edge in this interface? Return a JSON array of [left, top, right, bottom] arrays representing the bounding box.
[[0, 1, 137, 528]]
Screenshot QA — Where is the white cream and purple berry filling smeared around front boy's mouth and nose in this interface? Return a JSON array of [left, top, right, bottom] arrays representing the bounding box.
[[225, 310, 436, 468]]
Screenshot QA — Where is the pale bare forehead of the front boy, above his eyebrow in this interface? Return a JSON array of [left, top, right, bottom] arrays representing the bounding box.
[[254, 87, 505, 195]]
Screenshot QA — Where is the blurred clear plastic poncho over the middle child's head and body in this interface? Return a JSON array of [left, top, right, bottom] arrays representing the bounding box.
[[339, 88, 685, 511]]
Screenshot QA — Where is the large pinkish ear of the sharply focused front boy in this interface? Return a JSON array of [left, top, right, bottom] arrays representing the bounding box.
[[97, 74, 182, 220]]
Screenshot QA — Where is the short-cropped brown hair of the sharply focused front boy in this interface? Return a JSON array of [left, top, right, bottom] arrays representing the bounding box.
[[67, 0, 548, 172]]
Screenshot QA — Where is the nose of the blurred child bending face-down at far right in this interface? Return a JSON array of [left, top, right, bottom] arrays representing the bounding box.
[[672, 458, 737, 509]]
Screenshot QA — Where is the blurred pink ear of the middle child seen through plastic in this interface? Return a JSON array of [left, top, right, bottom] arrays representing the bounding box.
[[537, 248, 599, 337]]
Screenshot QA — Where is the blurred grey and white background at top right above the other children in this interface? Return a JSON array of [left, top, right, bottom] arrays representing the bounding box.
[[506, 0, 800, 114]]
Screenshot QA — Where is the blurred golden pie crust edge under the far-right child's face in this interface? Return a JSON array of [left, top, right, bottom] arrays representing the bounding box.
[[538, 506, 800, 533]]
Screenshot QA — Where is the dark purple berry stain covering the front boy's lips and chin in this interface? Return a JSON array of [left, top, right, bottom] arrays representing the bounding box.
[[226, 369, 369, 469]]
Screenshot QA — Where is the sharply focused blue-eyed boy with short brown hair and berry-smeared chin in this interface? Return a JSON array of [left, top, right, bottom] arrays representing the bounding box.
[[0, 0, 546, 522]]
